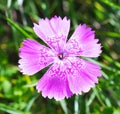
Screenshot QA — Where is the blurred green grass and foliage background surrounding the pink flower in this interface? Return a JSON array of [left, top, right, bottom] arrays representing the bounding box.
[[0, 0, 120, 114]]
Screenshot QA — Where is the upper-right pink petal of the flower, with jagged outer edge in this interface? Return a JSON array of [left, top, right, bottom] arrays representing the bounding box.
[[66, 24, 101, 57]]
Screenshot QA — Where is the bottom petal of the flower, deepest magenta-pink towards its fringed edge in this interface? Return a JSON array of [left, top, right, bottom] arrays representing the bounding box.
[[36, 63, 72, 100]]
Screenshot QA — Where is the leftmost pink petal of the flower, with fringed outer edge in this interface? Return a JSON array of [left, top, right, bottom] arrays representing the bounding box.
[[19, 39, 54, 75]]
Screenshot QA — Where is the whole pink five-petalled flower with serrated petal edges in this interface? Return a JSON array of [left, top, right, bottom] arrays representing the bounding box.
[[19, 16, 101, 100]]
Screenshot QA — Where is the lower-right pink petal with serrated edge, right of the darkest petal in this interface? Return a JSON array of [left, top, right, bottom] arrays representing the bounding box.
[[67, 57, 101, 94]]
